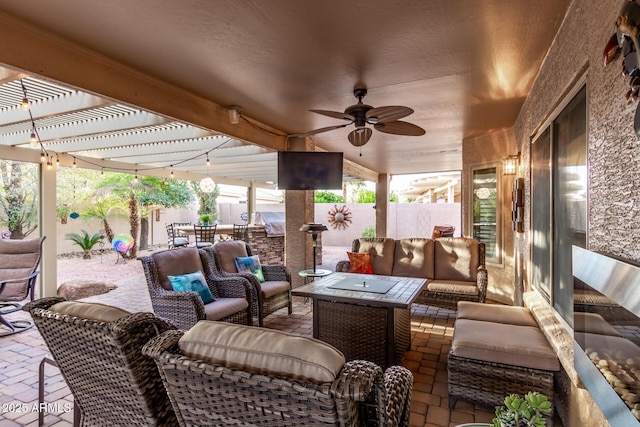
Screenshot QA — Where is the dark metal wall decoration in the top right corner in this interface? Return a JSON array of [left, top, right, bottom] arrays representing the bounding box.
[[602, 0, 640, 136]]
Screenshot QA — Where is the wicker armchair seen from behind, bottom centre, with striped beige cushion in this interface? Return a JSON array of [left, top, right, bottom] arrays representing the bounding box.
[[143, 322, 413, 427]]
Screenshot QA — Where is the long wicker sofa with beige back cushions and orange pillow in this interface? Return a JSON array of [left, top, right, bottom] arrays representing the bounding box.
[[336, 237, 488, 310]]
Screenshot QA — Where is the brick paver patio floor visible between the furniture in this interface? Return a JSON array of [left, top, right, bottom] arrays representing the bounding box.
[[0, 275, 493, 427]]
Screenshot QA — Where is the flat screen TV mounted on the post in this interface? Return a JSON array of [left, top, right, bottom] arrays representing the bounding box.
[[278, 151, 342, 190]]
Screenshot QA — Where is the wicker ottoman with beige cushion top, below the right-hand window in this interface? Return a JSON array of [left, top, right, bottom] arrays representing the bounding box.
[[448, 303, 560, 420]]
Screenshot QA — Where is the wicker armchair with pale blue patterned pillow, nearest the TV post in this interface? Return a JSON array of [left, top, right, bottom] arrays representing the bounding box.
[[201, 240, 293, 326]]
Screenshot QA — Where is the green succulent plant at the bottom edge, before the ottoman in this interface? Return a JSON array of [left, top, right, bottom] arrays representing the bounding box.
[[493, 392, 551, 427]]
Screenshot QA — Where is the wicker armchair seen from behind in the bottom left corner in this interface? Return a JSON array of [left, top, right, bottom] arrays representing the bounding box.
[[24, 298, 177, 426]]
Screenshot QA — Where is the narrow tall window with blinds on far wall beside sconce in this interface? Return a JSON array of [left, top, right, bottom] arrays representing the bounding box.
[[471, 166, 502, 263]]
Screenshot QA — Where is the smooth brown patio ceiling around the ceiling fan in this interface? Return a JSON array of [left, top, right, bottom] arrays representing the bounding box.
[[0, 0, 570, 182]]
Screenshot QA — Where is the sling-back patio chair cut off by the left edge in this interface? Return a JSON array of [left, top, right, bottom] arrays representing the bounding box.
[[0, 237, 45, 336]]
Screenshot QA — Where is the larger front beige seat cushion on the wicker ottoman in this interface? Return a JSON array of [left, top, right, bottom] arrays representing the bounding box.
[[451, 319, 560, 371]]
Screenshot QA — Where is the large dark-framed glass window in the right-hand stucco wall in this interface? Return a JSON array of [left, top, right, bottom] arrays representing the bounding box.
[[531, 86, 588, 324]]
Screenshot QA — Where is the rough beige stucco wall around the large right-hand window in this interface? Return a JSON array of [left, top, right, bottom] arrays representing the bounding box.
[[463, 0, 640, 426]]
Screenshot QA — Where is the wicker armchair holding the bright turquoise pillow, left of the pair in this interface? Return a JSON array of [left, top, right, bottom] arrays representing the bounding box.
[[138, 247, 253, 330]]
